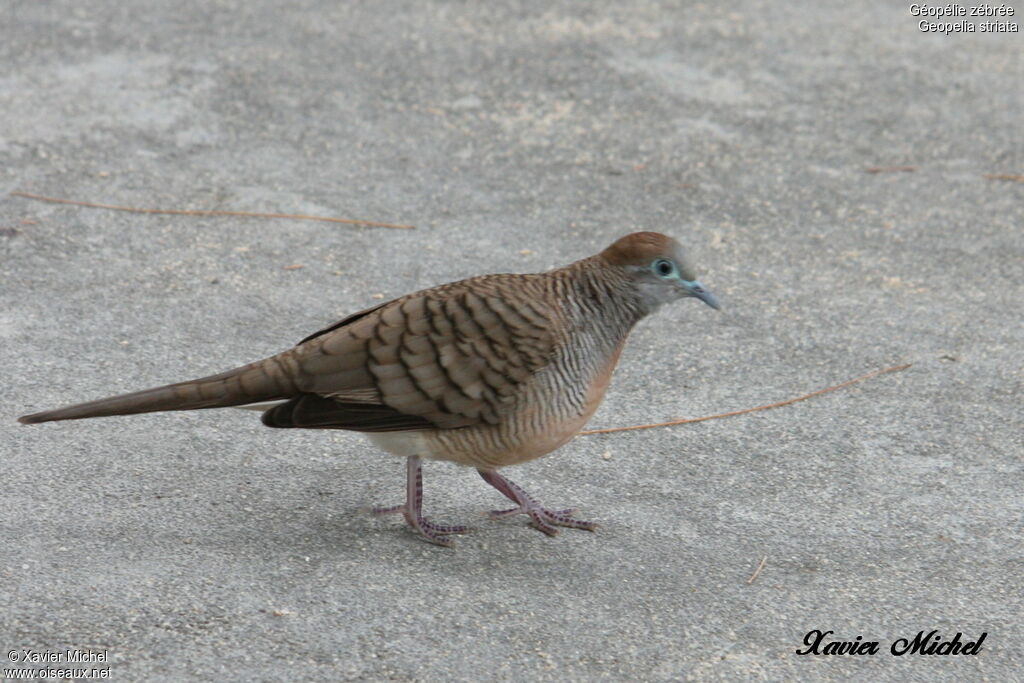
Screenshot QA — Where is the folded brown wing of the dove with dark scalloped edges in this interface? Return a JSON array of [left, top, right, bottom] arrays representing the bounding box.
[[263, 275, 565, 431]]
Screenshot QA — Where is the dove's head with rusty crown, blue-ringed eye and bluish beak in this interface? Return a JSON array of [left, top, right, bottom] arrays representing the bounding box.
[[600, 232, 719, 311]]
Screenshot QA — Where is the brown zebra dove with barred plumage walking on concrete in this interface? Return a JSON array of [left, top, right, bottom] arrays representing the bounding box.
[[18, 232, 718, 546]]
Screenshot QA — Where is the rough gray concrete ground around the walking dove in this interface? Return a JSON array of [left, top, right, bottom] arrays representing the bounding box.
[[0, 0, 1024, 681]]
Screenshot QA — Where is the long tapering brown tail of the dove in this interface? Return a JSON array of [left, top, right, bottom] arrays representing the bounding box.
[[17, 356, 296, 425]]
